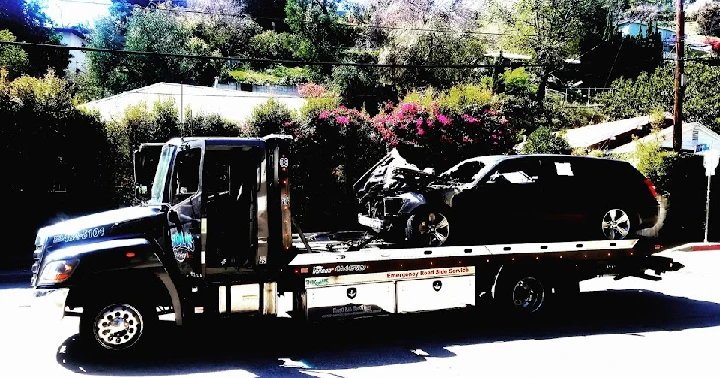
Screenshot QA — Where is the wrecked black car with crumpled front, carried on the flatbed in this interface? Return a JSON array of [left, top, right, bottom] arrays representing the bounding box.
[[354, 150, 659, 247]]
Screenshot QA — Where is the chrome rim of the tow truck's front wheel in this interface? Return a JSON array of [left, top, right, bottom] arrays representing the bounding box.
[[94, 304, 143, 350]]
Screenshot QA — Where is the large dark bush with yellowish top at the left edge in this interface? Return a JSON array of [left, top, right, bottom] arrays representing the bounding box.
[[0, 69, 114, 261]]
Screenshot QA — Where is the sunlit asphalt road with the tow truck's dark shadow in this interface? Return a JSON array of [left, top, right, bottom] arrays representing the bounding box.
[[0, 251, 720, 378]]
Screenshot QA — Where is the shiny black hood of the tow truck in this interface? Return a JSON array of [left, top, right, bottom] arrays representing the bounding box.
[[35, 207, 161, 245]]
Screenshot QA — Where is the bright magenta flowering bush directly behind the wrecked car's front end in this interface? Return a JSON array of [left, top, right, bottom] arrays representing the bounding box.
[[372, 102, 517, 169]]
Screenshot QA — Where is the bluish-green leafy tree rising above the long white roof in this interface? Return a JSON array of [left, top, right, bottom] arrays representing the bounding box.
[[88, 0, 260, 94]]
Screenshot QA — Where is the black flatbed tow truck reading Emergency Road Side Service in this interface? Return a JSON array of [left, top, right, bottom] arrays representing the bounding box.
[[32, 135, 682, 354]]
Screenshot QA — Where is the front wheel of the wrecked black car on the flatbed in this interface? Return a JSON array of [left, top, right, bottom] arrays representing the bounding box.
[[405, 208, 451, 248]]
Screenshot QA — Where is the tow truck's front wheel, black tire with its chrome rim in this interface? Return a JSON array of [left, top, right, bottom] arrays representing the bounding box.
[[80, 297, 159, 356]]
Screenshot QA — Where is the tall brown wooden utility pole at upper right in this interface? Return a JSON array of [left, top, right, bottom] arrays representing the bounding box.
[[673, 0, 685, 152]]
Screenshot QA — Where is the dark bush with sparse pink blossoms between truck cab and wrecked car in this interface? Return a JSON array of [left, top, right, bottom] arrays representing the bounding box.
[[284, 102, 385, 230]]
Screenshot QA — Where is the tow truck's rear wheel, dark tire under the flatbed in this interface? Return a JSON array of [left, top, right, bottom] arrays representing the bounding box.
[[493, 266, 552, 319]]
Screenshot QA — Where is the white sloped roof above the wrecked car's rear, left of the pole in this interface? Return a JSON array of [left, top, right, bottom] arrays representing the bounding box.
[[565, 116, 650, 148]]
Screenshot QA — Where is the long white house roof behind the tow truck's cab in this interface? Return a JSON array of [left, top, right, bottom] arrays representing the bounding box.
[[81, 83, 306, 123]]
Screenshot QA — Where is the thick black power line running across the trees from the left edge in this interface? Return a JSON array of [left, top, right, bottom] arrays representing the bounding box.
[[0, 41, 544, 69]]
